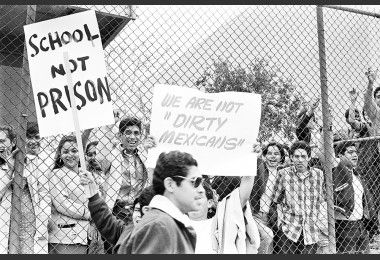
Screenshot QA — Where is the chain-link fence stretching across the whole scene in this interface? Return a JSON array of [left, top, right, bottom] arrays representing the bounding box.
[[0, 5, 380, 254]]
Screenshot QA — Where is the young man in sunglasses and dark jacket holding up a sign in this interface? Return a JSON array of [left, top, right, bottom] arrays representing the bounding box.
[[81, 151, 205, 254]]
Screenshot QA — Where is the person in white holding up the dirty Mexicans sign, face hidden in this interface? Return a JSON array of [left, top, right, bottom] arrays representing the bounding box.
[[189, 144, 260, 254]]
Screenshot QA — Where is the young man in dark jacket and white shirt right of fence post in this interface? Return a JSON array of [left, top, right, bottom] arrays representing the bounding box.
[[333, 141, 375, 253]]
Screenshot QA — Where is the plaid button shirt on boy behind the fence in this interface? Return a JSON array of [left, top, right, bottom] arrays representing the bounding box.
[[273, 166, 325, 245]]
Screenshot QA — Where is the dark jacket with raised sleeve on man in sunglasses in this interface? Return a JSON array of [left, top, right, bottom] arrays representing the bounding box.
[[88, 194, 196, 254]]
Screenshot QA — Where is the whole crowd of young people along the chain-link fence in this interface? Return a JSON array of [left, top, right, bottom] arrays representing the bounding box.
[[0, 70, 380, 254]]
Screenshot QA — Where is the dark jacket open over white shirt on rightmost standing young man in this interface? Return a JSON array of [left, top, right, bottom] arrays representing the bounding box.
[[333, 163, 375, 219]]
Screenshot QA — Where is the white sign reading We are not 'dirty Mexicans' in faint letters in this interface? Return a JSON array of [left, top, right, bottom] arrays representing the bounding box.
[[147, 85, 261, 176]]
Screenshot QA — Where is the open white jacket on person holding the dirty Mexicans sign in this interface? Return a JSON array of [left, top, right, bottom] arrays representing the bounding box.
[[212, 189, 260, 254]]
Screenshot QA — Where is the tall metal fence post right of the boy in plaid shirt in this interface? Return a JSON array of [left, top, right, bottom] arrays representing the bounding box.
[[317, 6, 336, 254]]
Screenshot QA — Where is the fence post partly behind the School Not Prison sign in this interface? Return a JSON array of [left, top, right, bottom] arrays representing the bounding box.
[[9, 5, 36, 254]]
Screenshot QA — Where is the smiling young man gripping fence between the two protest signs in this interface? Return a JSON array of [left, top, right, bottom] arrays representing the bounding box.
[[96, 117, 155, 224]]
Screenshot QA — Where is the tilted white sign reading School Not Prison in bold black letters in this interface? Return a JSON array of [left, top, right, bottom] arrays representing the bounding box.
[[24, 10, 114, 136]]
